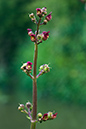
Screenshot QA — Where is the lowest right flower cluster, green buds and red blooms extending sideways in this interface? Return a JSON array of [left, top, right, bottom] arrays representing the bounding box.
[[38, 112, 57, 123]]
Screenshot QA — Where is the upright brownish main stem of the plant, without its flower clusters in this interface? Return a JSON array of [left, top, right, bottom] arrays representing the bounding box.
[[30, 18, 41, 129]]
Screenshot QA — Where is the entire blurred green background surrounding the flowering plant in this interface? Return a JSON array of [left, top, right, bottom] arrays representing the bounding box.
[[0, 0, 86, 129]]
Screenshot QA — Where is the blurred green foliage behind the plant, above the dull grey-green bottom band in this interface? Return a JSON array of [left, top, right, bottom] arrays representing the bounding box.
[[0, 0, 86, 104]]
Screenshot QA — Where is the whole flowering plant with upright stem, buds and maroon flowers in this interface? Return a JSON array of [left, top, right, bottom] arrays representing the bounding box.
[[18, 7, 57, 129]]
